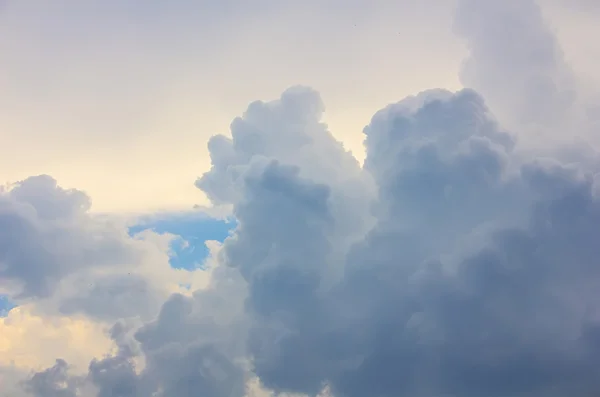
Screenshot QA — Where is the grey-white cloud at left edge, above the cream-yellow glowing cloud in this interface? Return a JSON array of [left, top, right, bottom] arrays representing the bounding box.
[[0, 175, 178, 322]]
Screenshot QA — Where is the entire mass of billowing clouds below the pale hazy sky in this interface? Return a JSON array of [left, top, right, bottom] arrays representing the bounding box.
[[0, 0, 600, 397]]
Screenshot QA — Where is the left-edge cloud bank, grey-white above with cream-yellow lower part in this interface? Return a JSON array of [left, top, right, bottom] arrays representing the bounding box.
[[0, 175, 224, 390]]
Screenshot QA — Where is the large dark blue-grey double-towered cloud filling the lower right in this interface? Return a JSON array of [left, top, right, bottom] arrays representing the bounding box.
[[206, 86, 599, 396]]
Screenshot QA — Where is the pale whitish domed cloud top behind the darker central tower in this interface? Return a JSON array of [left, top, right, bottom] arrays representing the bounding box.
[[196, 86, 374, 252]]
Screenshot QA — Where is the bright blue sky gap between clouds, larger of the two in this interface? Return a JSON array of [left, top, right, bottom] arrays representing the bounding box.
[[129, 212, 236, 270]]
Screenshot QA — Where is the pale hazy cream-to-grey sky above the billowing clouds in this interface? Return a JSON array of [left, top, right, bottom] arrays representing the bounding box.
[[0, 0, 600, 211]]
